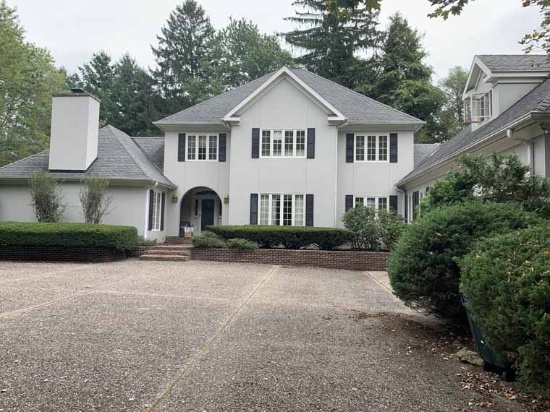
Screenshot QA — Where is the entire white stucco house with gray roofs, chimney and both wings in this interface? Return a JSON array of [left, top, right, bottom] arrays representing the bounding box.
[[0, 56, 550, 241]]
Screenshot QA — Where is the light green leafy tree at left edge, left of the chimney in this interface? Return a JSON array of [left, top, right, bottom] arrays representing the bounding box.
[[0, 0, 65, 166]]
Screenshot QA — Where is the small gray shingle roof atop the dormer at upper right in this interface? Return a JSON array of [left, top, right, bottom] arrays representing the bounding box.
[[477, 54, 550, 72]]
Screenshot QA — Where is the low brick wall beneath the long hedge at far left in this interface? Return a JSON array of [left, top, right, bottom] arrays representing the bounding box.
[[0, 245, 126, 262]]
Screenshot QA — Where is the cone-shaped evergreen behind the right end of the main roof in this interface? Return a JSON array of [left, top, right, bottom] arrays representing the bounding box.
[[370, 13, 444, 142]]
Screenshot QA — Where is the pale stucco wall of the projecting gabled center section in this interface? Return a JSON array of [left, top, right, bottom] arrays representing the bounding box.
[[228, 79, 337, 226]]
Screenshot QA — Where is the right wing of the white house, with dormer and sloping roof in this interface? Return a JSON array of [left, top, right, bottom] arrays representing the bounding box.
[[397, 55, 550, 220]]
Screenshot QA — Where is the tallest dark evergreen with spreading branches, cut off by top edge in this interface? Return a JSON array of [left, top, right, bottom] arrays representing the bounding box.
[[284, 0, 380, 88]]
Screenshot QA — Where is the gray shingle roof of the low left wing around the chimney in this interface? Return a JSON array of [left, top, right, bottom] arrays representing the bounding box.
[[0, 126, 176, 188]]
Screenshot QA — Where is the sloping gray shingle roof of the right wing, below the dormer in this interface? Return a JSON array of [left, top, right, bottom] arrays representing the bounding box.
[[398, 80, 550, 185]]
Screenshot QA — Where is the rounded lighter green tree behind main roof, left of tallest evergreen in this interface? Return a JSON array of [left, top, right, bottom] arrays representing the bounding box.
[[214, 19, 293, 89]]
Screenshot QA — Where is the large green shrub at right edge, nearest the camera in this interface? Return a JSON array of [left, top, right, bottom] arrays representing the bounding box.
[[460, 223, 550, 396]]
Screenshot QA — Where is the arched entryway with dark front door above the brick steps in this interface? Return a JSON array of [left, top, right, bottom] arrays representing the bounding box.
[[180, 187, 222, 234]]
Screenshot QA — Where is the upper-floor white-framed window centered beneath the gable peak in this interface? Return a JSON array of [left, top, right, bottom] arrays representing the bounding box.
[[260, 129, 306, 158]]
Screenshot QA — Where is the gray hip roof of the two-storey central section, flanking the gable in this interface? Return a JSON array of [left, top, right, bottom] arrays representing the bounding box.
[[156, 69, 424, 125]]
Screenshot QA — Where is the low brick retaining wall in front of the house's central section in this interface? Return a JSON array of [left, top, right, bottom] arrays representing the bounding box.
[[191, 248, 390, 271]]
